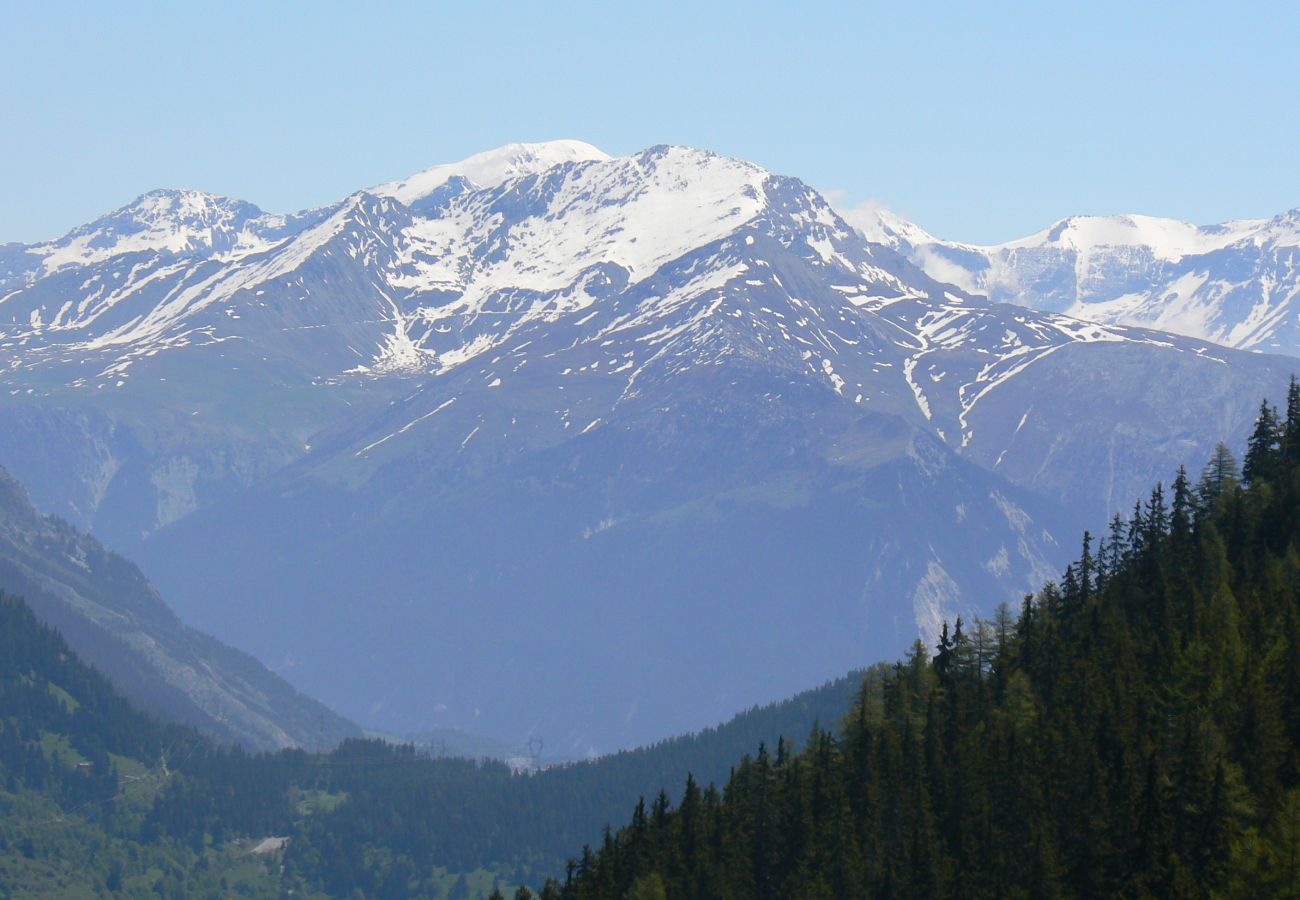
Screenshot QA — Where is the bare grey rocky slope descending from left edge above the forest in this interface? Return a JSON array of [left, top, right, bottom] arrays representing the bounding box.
[[0, 470, 360, 749]]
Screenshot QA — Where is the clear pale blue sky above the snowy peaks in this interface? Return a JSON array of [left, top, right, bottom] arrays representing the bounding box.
[[0, 0, 1300, 242]]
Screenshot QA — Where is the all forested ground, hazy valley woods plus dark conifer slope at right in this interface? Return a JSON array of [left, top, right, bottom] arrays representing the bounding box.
[[0, 381, 1300, 900]]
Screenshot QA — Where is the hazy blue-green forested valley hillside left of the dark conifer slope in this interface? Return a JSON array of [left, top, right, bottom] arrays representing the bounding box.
[[0, 580, 863, 897]]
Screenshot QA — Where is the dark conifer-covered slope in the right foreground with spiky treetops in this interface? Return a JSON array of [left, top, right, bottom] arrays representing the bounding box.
[[556, 380, 1300, 900]]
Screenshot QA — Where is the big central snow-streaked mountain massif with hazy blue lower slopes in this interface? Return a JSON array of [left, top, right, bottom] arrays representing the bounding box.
[[0, 142, 1294, 754]]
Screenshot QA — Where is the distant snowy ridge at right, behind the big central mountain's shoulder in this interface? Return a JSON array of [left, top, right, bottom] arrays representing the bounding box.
[[852, 209, 1300, 356]]
